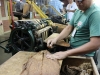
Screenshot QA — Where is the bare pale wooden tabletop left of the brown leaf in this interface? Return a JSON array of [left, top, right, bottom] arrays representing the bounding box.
[[0, 51, 62, 75]]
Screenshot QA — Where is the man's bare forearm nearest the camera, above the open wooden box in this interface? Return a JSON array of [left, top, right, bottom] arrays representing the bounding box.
[[66, 39, 100, 56]]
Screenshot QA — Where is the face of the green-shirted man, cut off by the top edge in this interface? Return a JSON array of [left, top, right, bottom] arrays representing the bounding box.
[[75, 0, 92, 11]]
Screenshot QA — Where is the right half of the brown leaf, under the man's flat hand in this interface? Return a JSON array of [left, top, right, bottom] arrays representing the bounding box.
[[42, 50, 62, 75]]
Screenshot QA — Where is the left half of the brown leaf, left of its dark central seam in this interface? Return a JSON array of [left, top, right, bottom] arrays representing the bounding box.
[[21, 52, 43, 75]]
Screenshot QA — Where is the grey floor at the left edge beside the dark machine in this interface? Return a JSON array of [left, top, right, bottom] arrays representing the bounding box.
[[0, 33, 12, 65]]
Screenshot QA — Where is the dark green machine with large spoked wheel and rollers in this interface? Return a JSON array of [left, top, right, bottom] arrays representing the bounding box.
[[5, 19, 54, 54]]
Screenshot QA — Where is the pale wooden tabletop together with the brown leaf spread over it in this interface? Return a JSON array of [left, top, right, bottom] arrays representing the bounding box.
[[0, 51, 62, 75]]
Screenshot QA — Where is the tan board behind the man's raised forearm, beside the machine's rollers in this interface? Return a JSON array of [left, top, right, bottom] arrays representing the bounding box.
[[44, 33, 70, 47]]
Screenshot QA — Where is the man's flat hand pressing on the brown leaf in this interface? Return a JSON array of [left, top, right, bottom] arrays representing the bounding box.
[[46, 51, 68, 59]]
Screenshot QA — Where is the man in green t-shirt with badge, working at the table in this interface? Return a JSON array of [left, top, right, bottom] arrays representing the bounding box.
[[47, 0, 100, 72]]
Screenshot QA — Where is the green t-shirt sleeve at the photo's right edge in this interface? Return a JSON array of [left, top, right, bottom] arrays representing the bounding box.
[[89, 11, 100, 37]]
